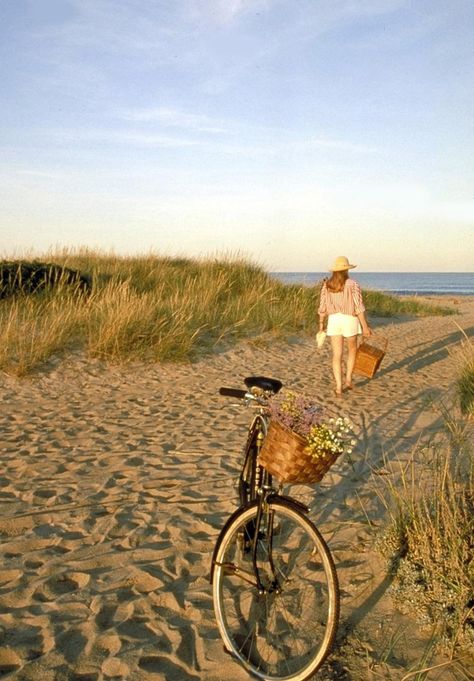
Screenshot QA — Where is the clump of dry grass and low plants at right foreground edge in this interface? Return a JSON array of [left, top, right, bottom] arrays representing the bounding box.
[[377, 386, 474, 657]]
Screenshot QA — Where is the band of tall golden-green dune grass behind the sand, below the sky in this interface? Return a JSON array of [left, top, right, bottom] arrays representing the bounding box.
[[0, 249, 456, 375]]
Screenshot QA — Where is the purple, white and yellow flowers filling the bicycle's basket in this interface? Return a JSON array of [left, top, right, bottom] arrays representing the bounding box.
[[270, 391, 356, 465]]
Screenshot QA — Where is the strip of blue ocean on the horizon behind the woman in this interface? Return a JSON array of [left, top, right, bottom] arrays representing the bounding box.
[[270, 271, 474, 296]]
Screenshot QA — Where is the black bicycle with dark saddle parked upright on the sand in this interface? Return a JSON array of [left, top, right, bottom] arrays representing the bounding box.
[[210, 376, 340, 681]]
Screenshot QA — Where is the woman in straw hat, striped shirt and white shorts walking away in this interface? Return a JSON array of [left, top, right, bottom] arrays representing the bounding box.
[[318, 255, 372, 397]]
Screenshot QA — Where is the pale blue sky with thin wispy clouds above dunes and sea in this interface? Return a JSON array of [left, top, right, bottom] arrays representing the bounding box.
[[0, 0, 474, 272]]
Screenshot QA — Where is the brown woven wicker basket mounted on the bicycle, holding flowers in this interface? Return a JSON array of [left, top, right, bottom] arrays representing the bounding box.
[[258, 421, 339, 484]]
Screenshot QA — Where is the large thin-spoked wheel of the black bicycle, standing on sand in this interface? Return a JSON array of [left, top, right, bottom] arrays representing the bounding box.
[[212, 497, 340, 681]]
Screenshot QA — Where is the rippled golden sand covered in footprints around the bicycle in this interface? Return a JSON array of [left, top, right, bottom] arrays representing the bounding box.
[[0, 297, 474, 681]]
